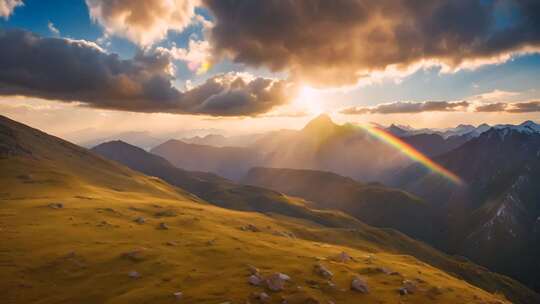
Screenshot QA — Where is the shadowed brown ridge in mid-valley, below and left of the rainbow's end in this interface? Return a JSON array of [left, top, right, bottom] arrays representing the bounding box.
[[243, 168, 432, 239]]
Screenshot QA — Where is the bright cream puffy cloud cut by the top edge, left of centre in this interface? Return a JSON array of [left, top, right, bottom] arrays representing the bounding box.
[[86, 0, 198, 46]]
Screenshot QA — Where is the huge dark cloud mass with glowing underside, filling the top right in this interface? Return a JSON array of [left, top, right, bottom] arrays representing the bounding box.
[[202, 0, 540, 86]]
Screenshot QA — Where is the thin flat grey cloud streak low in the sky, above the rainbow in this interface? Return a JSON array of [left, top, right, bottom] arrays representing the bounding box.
[[340, 101, 469, 115]]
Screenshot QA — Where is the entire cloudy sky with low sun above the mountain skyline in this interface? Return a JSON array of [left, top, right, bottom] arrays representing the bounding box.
[[0, 0, 540, 137]]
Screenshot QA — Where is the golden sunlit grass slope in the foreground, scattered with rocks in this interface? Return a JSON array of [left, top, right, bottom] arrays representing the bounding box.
[[0, 118, 534, 303]]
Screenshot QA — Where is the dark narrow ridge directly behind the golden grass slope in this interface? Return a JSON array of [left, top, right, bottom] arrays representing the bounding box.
[[92, 141, 362, 228]]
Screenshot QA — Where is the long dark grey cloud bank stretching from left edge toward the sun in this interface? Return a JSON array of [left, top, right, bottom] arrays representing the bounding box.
[[0, 30, 294, 116]]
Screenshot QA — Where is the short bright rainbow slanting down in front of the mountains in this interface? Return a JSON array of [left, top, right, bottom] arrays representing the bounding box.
[[361, 126, 463, 185]]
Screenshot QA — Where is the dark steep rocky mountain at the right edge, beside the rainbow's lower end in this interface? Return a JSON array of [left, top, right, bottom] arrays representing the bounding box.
[[395, 126, 540, 290]]
